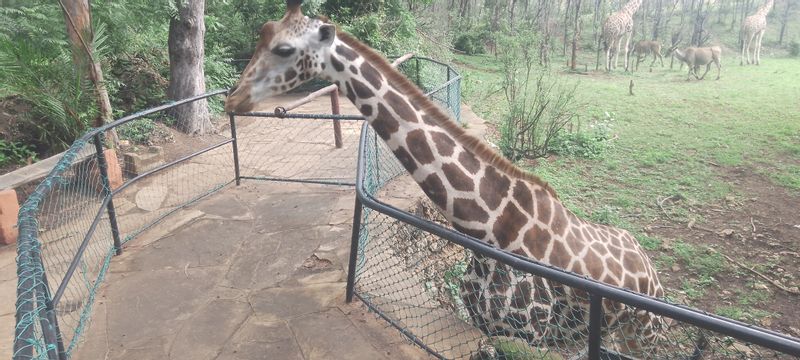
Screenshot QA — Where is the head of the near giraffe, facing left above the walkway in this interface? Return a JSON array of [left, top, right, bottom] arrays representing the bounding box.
[[225, 0, 336, 112]]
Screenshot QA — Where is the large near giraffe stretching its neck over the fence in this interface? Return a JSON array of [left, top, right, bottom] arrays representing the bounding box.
[[225, 0, 668, 349]]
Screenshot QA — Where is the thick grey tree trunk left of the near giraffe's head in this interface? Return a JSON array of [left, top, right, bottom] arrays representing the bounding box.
[[167, 0, 212, 134]]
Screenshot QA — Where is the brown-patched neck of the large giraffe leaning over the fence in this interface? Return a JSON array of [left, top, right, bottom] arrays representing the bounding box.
[[323, 33, 568, 248]]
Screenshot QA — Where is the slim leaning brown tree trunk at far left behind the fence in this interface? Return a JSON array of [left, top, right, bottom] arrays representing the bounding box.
[[61, 0, 113, 127]]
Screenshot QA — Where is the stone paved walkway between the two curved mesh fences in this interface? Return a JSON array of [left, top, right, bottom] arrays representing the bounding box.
[[0, 91, 490, 359]]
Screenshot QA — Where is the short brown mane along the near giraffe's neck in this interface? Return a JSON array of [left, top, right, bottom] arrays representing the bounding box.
[[336, 27, 558, 198]]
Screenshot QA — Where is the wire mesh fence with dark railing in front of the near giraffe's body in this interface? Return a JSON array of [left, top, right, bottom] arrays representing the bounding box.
[[348, 124, 800, 359]]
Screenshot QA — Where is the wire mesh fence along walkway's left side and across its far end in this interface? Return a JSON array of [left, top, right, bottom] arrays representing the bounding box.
[[14, 54, 460, 359]]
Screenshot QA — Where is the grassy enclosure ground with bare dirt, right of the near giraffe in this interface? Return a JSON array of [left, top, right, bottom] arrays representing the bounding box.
[[454, 51, 800, 336]]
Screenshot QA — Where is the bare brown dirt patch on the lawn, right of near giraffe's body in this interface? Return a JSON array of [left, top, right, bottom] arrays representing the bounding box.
[[650, 167, 800, 336]]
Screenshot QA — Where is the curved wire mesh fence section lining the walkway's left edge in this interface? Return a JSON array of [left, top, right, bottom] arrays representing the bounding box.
[[14, 91, 234, 359]]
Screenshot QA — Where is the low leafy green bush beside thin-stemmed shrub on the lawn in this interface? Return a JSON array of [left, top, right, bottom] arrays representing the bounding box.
[[550, 112, 614, 159]]
